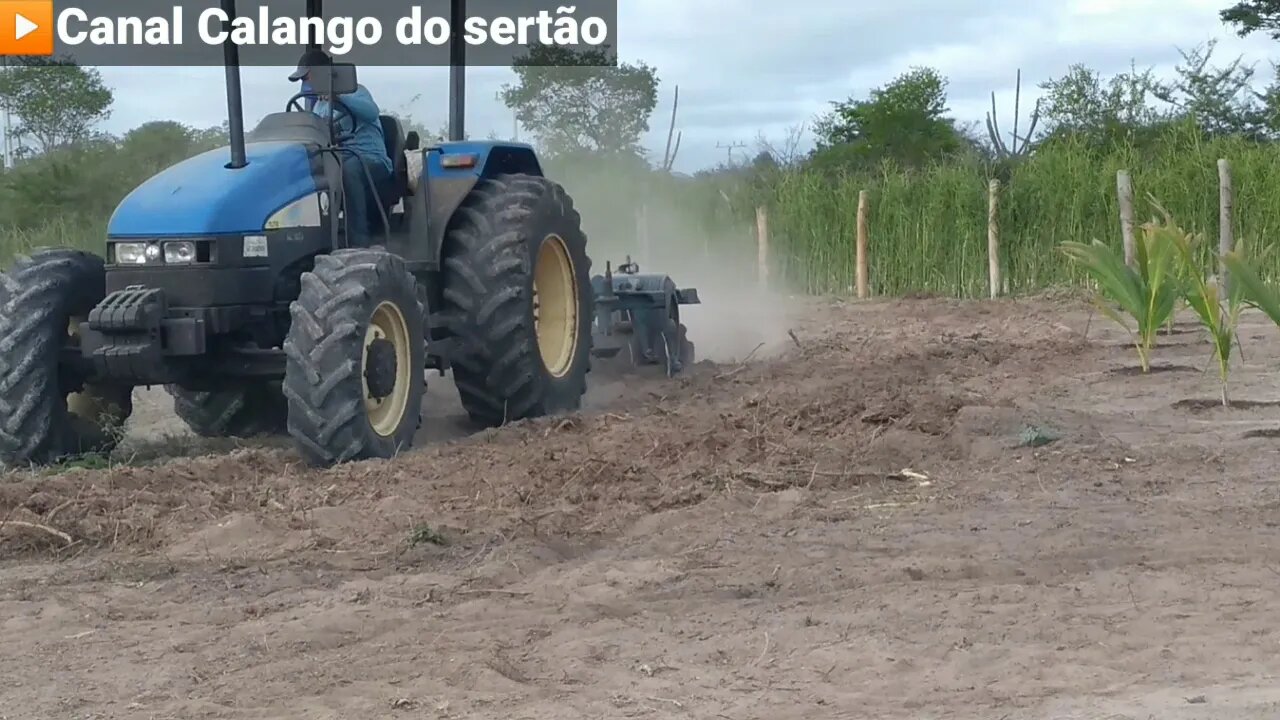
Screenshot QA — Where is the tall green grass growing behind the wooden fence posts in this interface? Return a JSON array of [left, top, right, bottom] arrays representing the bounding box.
[[769, 128, 1280, 297]]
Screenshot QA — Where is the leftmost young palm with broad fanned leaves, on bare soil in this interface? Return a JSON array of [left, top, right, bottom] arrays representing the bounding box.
[[1062, 213, 1180, 373]]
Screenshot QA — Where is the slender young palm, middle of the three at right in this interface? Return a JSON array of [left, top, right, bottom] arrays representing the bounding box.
[[1167, 210, 1244, 407]]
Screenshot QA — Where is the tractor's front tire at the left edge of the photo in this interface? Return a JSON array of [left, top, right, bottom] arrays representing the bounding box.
[[0, 249, 133, 466]]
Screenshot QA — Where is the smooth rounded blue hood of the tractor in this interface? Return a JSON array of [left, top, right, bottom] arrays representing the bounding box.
[[106, 142, 323, 238]]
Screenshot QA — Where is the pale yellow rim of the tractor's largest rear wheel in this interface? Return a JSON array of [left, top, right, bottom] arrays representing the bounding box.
[[534, 234, 579, 378]]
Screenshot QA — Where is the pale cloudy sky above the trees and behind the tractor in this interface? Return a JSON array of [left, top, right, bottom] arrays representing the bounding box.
[[92, 0, 1280, 172]]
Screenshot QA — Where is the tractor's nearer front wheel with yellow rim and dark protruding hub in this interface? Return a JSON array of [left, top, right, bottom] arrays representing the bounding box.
[[284, 249, 426, 466]]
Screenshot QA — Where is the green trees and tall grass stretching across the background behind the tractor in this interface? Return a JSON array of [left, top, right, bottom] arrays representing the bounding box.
[[0, 0, 1280, 296]]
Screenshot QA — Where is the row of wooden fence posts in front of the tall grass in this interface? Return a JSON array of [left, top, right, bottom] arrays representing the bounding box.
[[711, 158, 1235, 300]]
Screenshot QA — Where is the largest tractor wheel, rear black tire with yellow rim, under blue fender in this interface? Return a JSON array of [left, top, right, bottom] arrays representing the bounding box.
[[443, 174, 595, 427]]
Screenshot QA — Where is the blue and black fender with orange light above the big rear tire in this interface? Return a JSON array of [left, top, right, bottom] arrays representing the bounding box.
[[406, 141, 543, 270]]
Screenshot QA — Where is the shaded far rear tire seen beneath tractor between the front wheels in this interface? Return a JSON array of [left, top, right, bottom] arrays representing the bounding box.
[[165, 382, 289, 439]]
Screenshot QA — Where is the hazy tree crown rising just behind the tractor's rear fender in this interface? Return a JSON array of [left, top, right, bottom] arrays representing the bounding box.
[[498, 45, 658, 156]]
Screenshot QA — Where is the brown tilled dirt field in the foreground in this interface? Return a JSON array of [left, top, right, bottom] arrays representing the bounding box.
[[0, 293, 1280, 720]]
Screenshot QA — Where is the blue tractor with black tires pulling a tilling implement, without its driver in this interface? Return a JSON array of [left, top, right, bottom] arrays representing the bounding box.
[[0, 0, 699, 466]]
